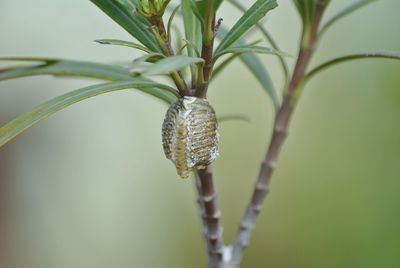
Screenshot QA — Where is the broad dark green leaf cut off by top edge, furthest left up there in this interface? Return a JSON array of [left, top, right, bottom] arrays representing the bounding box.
[[90, 0, 161, 52]]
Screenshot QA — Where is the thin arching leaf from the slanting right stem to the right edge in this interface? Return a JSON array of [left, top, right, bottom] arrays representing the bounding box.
[[304, 51, 400, 81]]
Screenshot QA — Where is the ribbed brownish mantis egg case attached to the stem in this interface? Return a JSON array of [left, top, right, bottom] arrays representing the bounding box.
[[162, 97, 219, 179]]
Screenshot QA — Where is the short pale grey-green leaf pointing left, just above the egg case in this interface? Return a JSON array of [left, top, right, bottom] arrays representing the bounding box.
[[143, 55, 204, 75]]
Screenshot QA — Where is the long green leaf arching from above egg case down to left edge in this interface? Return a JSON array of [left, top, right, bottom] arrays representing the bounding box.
[[0, 79, 176, 147]]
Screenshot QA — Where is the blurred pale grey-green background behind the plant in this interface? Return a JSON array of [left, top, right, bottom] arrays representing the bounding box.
[[0, 0, 400, 268]]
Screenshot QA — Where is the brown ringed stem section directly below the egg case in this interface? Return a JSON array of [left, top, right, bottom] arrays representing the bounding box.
[[197, 166, 224, 268]]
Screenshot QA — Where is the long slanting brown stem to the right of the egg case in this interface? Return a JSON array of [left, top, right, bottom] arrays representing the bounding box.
[[231, 0, 326, 267]]
